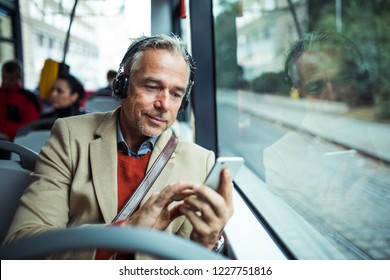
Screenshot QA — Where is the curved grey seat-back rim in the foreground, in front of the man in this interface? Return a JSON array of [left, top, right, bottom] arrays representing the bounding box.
[[0, 225, 228, 260]]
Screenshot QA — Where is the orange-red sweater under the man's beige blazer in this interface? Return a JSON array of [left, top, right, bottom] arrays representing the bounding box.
[[95, 151, 151, 260]]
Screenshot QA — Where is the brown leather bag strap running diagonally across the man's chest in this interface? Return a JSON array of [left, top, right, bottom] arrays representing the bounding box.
[[112, 134, 179, 223]]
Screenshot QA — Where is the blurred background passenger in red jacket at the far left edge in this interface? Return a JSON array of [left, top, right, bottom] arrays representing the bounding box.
[[0, 60, 41, 141]]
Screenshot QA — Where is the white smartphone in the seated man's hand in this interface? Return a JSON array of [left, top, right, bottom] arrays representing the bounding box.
[[203, 157, 244, 190]]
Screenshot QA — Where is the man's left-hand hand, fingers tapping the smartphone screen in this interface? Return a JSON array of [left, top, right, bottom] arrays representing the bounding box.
[[124, 182, 195, 230]]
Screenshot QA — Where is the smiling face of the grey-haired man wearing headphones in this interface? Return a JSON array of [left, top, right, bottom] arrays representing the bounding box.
[[120, 50, 189, 141]]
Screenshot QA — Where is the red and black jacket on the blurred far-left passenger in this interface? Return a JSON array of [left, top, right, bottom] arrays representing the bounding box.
[[0, 86, 41, 141]]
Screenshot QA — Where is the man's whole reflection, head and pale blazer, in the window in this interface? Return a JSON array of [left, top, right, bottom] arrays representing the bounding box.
[[263, 30, 390, 259]]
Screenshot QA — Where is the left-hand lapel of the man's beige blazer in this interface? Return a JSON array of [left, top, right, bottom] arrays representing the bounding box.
[[89, 110, 118, 223]]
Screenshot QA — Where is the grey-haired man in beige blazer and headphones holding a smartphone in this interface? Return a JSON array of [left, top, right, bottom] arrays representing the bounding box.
[[6, 35, 233, 259]]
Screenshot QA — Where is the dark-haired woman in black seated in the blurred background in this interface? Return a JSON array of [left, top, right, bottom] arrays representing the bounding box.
[[38, 74, 85, 129]]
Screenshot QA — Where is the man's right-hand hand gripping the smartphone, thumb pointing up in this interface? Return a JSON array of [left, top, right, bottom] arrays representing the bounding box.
[[179, 168, 234, 249]]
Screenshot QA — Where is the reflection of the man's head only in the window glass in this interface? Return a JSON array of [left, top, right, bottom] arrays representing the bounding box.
[[285, 33, 369, 106]]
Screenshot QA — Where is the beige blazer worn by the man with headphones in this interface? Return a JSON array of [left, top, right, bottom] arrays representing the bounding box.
[[5, 109, 215, 259]]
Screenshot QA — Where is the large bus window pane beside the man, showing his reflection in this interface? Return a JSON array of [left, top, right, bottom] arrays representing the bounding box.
[[213, 0, 390, 259]]
